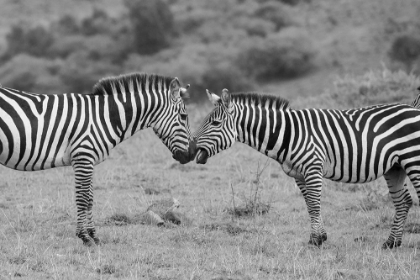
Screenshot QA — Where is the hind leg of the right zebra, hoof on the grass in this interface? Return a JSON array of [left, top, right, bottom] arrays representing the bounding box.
[[382, 166, 413, 249]]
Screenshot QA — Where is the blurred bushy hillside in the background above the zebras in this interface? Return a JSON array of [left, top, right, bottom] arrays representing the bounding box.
[[0, 0, 420, 102]]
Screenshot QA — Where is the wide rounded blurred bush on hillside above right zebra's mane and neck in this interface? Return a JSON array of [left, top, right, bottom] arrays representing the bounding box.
[[237, 28, 316, 81]]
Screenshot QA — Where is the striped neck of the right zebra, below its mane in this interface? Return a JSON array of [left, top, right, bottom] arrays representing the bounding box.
[[235, 104, 291, 163]]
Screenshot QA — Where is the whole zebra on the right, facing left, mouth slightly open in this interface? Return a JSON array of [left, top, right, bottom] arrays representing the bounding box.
[[193, 89, 420, 248]]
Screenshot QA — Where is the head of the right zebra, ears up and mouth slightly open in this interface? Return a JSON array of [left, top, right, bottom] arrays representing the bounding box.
[[194, 89, 238, 164]]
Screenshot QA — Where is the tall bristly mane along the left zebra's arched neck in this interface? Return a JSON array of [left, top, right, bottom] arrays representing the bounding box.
[[91, 73, 174, 95]]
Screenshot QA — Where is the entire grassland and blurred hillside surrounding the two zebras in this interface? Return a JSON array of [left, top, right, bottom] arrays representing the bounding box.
[[0, 0, 420, 280]]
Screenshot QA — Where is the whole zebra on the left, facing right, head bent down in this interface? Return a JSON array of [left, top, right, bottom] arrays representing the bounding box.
[[0, 73, 191, 246]]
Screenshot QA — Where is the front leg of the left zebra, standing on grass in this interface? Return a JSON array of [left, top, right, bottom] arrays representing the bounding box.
[[72, 160, 99, 246]]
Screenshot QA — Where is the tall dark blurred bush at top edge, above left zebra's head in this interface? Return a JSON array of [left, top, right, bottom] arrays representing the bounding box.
[[124, 0, 175, 54]]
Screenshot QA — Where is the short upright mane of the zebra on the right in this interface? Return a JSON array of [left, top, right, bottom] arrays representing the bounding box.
[[232, 92, 290, 110]]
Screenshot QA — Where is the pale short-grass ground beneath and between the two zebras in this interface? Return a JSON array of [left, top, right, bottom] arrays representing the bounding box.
[[0, 99, 420, 279]]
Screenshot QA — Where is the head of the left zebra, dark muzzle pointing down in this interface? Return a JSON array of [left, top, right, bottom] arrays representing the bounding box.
[[153, 78, 191, 164]]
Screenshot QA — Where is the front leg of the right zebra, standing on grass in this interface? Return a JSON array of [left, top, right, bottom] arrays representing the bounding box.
[[304, 167, 326, 246]]
